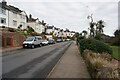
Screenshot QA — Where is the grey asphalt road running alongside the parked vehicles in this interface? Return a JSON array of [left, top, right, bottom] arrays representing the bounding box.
[[2, 41, 72, 78]]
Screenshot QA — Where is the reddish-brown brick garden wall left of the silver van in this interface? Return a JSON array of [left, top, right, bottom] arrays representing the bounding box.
[[2, 32, 26, 47]]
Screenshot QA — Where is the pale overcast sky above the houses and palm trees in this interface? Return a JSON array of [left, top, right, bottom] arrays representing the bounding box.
[[0, 0, 118, 36]]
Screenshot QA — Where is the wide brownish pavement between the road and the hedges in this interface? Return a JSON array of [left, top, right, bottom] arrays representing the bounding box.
[[47, 42, 90, 78]]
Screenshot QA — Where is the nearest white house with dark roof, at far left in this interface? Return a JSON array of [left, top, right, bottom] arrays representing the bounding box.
[[0, 0, 26, 29]]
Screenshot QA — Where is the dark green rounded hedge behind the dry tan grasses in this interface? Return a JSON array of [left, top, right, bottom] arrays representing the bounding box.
[[79, 39, 112, 54]]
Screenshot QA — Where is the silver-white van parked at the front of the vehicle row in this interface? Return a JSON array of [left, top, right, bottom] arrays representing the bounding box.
[[23, 36, 42, 48]]
